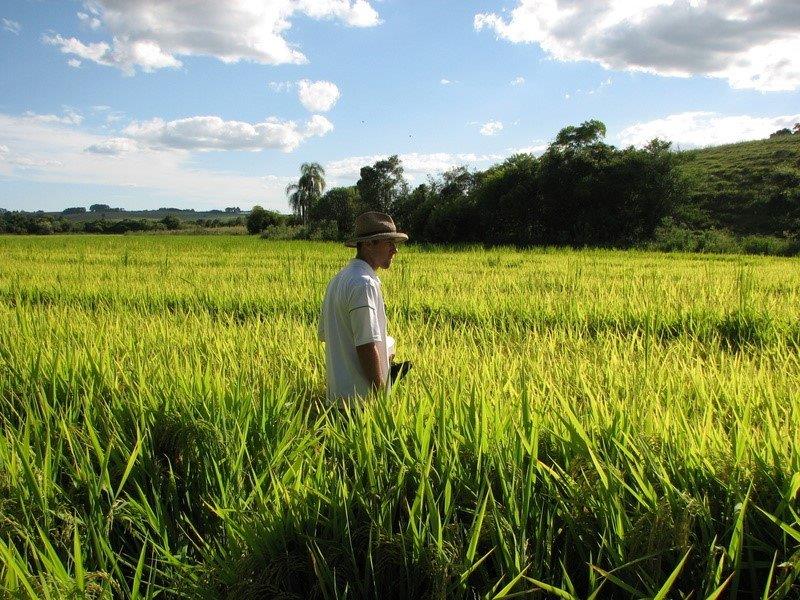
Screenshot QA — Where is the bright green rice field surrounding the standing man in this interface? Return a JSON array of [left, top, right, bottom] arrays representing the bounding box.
[[0, 236, 800, 599]]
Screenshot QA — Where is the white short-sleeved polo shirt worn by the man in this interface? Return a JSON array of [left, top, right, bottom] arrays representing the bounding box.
[[318, 258, 389, 400]]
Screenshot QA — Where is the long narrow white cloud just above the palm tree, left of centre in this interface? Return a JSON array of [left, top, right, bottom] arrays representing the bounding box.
[[123, 115, 333, 152]]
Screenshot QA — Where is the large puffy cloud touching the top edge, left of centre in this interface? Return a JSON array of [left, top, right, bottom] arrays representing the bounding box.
[[43, 0, 381, 75]]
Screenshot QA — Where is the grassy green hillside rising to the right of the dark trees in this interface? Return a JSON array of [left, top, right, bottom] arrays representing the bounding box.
[[678, 134, 800, 235]]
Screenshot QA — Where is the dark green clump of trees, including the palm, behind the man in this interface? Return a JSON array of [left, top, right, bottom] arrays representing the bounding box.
[[253, 120, 683, 246]]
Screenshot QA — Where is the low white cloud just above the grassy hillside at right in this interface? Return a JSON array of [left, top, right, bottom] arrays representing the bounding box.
[[617, 111, 800, 148]]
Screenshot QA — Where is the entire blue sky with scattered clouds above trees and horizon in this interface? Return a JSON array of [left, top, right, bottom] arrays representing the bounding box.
[[0, 0, 800, 212]]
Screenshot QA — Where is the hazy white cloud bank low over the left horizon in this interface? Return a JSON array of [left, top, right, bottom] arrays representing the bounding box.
[[0, 113, 288, 211]]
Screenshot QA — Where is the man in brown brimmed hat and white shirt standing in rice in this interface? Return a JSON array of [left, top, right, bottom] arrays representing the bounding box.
[[318, 212, 408, 400]]
